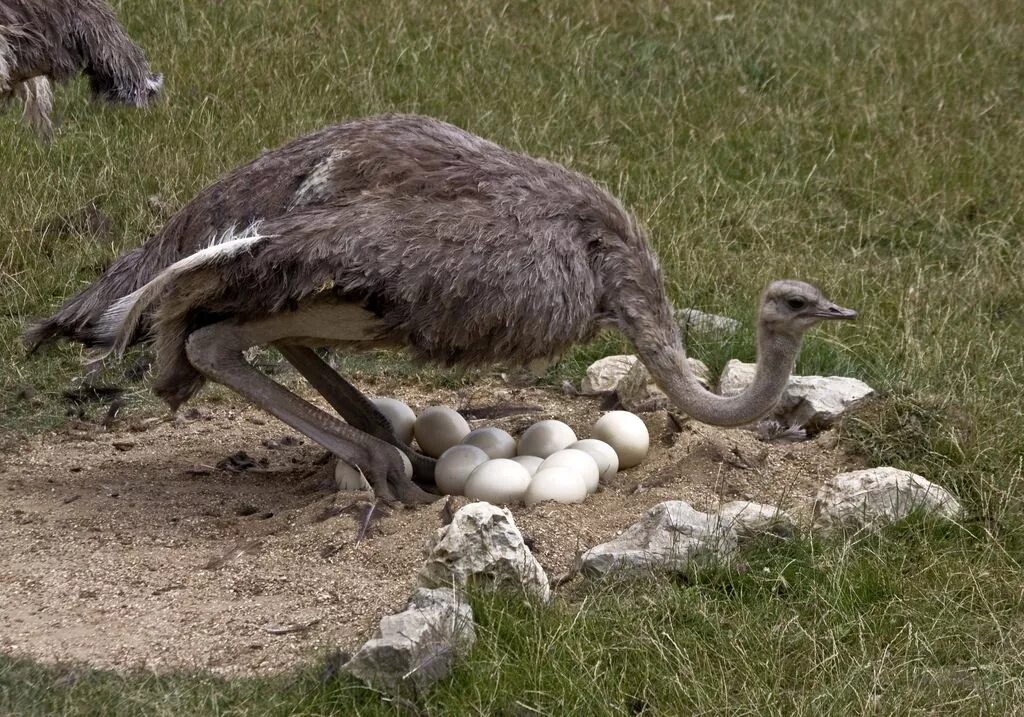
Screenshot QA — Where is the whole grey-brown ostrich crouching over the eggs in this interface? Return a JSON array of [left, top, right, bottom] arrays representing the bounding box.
[[26, 115, 856, 502]]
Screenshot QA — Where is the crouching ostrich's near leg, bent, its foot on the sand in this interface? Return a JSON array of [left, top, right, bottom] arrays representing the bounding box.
[[186, 322, 436, 503]]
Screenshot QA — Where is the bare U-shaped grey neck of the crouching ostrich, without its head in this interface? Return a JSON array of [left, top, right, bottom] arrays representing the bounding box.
[[637, 327, 800, 426]]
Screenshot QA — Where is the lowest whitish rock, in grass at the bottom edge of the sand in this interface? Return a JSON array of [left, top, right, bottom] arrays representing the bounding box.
[[344, 588, 476, 694]]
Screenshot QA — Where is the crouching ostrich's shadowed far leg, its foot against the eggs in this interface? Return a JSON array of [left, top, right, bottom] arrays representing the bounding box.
[[276, 343, 437, 484]]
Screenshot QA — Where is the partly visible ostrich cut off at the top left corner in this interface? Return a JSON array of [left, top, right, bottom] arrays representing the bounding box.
[[0, 0, 163, 138]]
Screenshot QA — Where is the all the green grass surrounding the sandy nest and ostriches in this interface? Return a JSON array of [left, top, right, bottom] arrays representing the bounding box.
[[0, 0, 1024, 715]]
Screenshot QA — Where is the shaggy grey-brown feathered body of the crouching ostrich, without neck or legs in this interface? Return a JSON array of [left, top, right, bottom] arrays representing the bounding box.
[[27, 115, 679, 406]]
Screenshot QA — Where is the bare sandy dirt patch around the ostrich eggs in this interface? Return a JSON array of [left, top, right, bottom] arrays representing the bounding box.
[[0, 377, 859, 674]]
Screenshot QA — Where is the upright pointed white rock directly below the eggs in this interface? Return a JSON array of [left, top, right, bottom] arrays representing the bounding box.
[[418, 503, 551, 600]]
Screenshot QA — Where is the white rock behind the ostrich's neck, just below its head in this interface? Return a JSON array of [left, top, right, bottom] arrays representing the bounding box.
[[718, 359, 874, 429]]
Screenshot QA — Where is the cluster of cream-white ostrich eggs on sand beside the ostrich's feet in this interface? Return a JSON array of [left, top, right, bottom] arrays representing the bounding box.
[[373, 398, 650, 505]]
